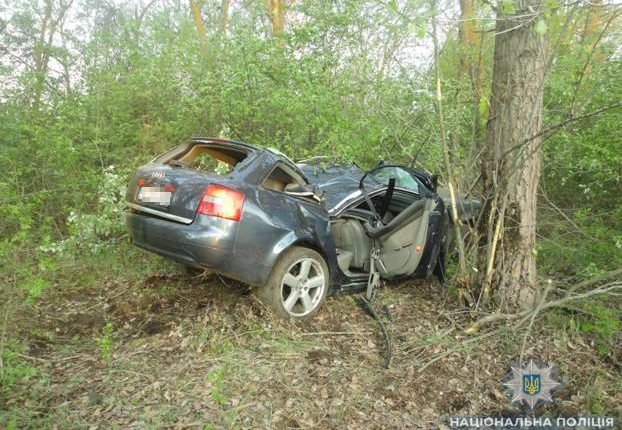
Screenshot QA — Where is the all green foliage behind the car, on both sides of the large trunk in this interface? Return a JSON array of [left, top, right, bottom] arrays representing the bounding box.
[[0, 0, 622, 322]]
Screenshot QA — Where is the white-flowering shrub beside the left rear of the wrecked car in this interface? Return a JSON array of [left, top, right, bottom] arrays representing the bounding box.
[[40, 166, 127, 255]]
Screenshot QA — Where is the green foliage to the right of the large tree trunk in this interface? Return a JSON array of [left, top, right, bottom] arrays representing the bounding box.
[[538, 10, 622, 279]]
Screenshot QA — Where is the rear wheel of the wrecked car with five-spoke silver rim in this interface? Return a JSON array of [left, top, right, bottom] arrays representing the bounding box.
[[259, 247, 330, 319]]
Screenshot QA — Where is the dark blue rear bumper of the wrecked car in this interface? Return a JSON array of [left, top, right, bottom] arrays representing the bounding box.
[[125, 212, 271, 285]]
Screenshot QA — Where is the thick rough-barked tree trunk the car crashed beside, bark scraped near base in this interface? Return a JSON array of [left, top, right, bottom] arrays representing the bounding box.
[[479, 0, 546, 309]]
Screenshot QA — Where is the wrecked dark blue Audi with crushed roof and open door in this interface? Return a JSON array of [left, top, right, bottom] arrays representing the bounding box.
[[126, 138, 478, 319]]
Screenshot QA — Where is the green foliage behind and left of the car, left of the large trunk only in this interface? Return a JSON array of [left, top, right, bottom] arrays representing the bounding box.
[[0, 1, 454, 268]]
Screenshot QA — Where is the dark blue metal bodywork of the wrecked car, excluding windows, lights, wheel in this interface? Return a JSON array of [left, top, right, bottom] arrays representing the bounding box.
[[126, 138, 460, 293]]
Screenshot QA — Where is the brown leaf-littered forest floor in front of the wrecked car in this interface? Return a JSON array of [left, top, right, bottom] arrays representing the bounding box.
[[0, 249, 622, 429]]
